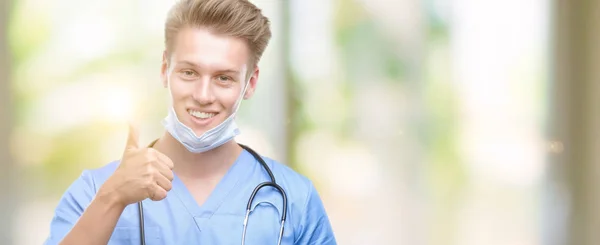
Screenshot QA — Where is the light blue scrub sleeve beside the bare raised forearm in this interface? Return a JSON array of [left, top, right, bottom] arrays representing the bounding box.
[[44, 171, 96, 245]]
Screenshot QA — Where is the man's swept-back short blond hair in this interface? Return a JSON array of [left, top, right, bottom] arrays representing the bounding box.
[[165, 0, 271, 67]]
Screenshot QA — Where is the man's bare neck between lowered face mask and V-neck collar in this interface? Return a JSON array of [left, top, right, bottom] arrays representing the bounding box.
[[154, 132, 243, 179]]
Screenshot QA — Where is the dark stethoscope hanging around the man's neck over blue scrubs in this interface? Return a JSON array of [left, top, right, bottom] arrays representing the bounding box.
[[138, 142, 287, 245]]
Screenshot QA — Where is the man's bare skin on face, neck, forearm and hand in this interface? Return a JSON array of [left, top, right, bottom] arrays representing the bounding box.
[[61, 28, 259, 244]]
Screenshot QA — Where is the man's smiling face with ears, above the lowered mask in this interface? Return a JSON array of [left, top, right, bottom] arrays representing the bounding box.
[[162, 28, 259, 136]]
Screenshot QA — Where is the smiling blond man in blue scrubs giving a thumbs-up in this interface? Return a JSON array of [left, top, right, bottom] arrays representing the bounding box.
[[46, 0, 336, 245]]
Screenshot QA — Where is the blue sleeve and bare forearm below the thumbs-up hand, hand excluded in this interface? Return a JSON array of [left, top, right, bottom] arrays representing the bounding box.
[[45, 171, 125, 245]]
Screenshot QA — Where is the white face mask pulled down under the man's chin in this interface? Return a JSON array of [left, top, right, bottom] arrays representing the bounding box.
[[162, 73, 250, 153]]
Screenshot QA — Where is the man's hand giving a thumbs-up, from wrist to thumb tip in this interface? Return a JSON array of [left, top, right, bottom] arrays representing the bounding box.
[[98, 125, 173, 206]]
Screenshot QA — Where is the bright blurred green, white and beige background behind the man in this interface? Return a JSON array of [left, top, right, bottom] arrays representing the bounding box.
[[0, 0, 600, 245]]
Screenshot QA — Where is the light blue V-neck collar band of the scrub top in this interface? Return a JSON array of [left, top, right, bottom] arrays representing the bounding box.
[[172, 150, 252, 221]]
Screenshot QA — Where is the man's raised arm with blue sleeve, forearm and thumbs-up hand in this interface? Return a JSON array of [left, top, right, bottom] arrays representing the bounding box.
[[46, 127, 173, 245]]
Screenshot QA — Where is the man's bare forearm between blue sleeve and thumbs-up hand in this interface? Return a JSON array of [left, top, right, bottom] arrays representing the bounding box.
[[60, 194, 125, 245]]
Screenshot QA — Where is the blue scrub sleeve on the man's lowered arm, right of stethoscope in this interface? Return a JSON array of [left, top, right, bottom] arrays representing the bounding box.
[[295, 184, 337, 245]]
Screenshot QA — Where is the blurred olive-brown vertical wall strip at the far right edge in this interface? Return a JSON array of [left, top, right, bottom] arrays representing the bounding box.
[[547, 0, 600, 245]]
